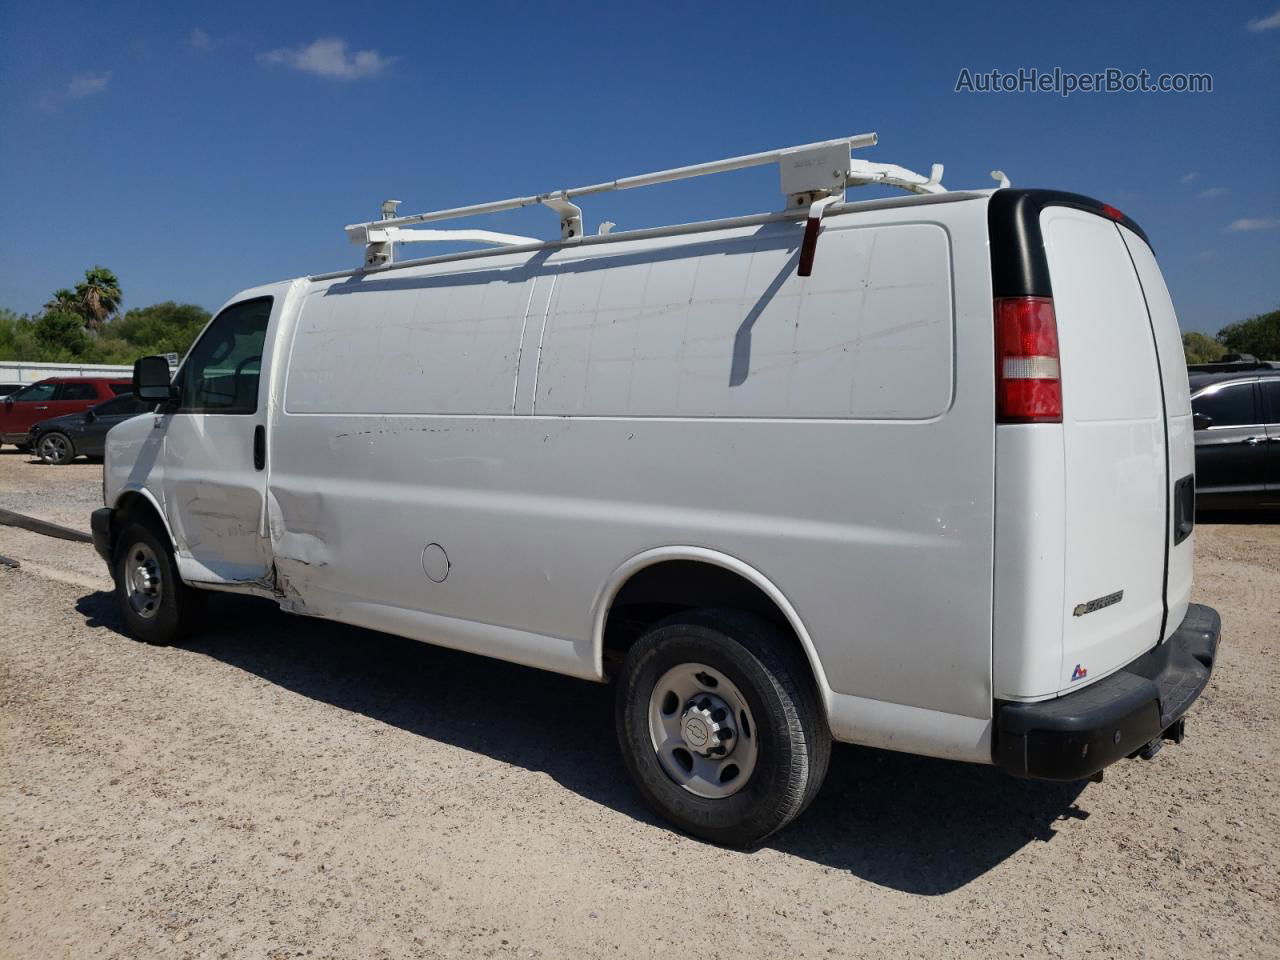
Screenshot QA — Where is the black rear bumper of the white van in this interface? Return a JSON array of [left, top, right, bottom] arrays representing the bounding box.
[[995, 603, 1222, 780]]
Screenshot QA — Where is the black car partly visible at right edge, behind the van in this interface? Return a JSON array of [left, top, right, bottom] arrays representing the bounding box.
[[1190, 365, 1280, 509]]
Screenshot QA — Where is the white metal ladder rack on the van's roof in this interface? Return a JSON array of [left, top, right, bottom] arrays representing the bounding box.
[[346, 133, 946, 276]]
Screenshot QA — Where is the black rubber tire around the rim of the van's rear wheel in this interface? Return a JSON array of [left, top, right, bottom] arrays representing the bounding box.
[[617, 622, 806, 846]]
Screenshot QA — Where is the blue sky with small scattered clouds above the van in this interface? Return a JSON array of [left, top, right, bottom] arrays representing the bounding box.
[[0, 0, 1280, 332]]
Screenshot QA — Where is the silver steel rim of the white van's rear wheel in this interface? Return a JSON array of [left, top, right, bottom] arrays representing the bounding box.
[[649, 663, 759, 800]]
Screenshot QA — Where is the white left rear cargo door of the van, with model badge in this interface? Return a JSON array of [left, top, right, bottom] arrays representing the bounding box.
[[1041, 206, 1171, 689]]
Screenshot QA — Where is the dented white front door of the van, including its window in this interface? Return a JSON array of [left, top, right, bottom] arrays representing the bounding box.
[[156, 297, 279, 584]]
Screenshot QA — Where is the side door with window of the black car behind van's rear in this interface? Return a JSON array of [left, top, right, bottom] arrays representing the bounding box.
[[1192, 381, 1268, 495]]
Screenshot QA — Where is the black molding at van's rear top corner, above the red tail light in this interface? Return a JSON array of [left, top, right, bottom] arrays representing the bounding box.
[[987, 189, 1151, 297]]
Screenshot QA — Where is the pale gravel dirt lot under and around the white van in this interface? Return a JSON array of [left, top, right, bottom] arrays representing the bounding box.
[[0, 447, 1280, 960]]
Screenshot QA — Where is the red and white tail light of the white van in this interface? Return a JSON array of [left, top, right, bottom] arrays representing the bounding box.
[[996, 297, 1062, 424]]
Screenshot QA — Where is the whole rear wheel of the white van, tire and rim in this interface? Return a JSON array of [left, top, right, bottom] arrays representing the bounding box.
[[616, 609, 831, 846]]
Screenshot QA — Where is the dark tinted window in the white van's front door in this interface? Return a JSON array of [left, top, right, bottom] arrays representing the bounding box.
[[178, 297, 271, 413]]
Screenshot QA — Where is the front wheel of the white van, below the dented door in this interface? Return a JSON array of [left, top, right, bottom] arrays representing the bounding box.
[[113, 521, 205, 645]]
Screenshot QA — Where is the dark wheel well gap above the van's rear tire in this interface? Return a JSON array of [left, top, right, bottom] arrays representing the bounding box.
[[603, 559, 818, 689]]
